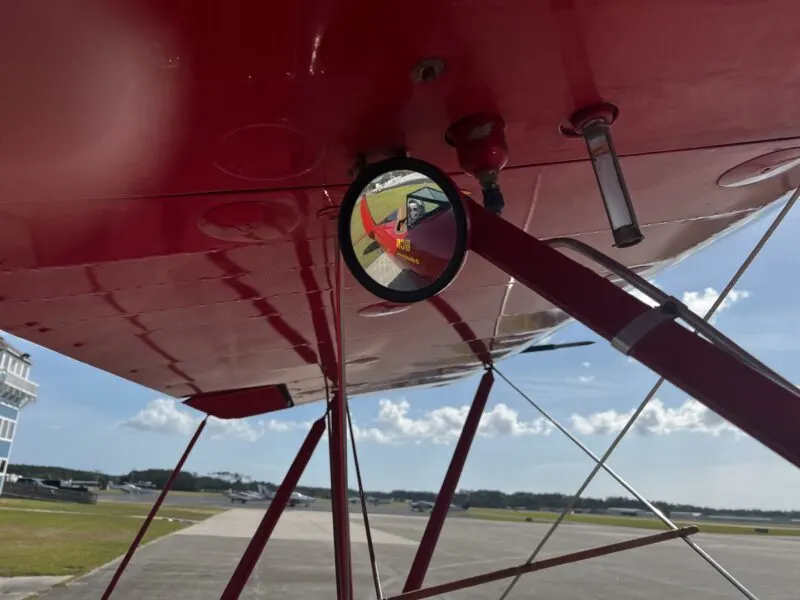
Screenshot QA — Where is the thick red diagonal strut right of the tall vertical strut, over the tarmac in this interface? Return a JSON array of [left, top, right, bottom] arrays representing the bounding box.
[[403, 371, 494, 593]]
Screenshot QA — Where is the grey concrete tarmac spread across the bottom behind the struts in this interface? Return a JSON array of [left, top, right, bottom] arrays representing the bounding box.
[[36, 508, 800, 600]]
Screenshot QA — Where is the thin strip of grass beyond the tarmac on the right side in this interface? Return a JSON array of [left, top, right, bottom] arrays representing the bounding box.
[[466, 508, 800, 536]]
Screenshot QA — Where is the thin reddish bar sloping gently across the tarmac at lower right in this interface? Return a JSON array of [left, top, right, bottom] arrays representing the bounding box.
[[387, 525, 699, 600]]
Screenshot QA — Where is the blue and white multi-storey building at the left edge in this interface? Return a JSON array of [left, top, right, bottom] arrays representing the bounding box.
[[0, 337, 39, 494]]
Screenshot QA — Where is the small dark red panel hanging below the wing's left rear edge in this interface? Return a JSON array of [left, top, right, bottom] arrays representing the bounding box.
[[183, 385, 292, 419]]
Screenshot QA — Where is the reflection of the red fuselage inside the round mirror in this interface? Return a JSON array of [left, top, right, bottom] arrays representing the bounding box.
[[360, 197, 456, 285]]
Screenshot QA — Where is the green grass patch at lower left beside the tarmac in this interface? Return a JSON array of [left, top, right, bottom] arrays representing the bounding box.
[[0, 499, 220, 577]]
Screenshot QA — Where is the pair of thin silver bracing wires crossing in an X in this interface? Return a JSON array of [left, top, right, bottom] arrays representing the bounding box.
[[494, 188, 800, 600]]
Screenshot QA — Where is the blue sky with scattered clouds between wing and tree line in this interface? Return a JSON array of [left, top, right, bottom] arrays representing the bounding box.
[[8, 198, 800, 509]]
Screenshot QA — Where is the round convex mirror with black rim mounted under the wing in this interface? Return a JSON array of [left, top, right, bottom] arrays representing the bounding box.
[[339, 158, 467, 303]]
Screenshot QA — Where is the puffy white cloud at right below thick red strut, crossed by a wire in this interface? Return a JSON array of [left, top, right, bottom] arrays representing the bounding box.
[[570, 398, 741, 436]]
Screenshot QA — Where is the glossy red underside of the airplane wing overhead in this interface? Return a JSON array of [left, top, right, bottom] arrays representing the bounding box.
[[0, 0, 800, 410]]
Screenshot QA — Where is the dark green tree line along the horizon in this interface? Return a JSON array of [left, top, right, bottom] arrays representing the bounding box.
[[8, 464, 800, 519]]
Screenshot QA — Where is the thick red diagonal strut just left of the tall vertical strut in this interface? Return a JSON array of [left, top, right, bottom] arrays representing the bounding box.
[[220, 417, 325, 600]]
